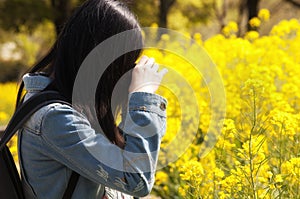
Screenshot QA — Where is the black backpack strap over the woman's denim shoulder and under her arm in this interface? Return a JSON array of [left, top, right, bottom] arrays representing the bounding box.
[[0, 91, 79, 199]]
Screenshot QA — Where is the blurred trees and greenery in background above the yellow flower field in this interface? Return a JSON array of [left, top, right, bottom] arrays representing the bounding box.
[[0, 0, 300, 82]]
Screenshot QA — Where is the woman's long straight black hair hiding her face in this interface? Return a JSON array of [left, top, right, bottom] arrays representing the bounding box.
[[16, 0, 143, 147]]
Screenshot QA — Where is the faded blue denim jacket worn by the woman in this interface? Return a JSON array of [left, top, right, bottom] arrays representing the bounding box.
[[18, 74, 167, 199]]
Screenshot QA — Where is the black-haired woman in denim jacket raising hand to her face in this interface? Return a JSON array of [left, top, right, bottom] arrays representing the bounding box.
[[17, 0, 167, 199]]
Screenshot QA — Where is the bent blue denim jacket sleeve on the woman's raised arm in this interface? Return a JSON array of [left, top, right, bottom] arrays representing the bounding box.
[[41, 92, 167, 197]]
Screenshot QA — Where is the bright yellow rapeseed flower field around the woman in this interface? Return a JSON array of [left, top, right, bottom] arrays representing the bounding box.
[[0, 14, 300, 199]]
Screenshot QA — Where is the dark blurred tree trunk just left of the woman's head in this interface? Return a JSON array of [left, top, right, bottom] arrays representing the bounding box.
[[51, 0, 72, 35]]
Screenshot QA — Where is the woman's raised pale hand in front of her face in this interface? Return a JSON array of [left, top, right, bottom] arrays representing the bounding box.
[[129, 56, 168, 93]]
